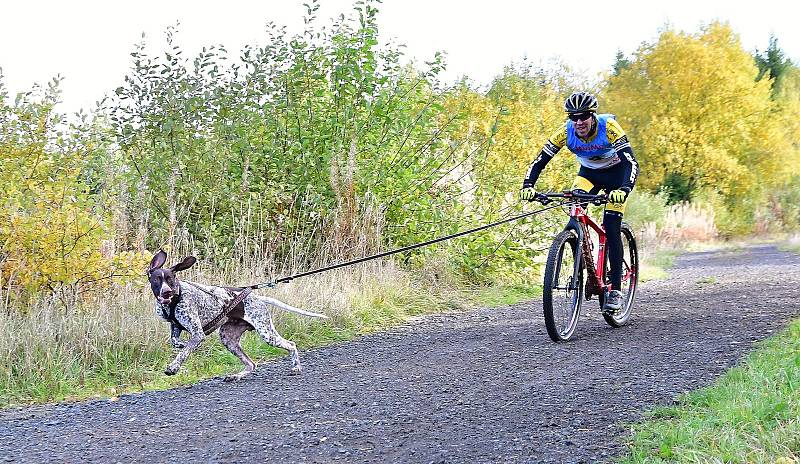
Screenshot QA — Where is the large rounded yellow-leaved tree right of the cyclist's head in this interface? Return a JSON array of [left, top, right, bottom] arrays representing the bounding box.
[[604, 23, 792, 197]]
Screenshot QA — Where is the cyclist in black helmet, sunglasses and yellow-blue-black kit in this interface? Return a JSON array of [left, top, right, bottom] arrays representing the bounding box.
[[520, 92, 639, 314]]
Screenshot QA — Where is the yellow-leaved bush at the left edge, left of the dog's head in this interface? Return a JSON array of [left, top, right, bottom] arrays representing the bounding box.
[[0, 92, 146, 302]]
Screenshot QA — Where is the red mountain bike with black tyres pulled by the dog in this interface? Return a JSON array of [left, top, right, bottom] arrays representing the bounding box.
[[534, 191, 639, 342]]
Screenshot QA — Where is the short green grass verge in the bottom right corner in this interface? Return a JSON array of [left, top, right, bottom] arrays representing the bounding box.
[[619, 320, 800, 464]]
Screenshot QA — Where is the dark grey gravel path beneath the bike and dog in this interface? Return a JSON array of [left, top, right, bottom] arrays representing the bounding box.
[[0, 245, 800, 463]]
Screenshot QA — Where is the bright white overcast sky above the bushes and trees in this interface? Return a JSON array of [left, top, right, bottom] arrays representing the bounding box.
[[0, 0, 800, 112]]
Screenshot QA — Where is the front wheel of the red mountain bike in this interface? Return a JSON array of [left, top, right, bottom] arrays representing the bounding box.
[[542, 229, 583, 342]]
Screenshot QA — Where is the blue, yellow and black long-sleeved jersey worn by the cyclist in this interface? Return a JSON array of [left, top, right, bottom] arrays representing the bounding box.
[[523, 114, 639, 193]]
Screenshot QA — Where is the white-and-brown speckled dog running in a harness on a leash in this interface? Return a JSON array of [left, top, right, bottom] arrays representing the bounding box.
[[147, 250, 328, 382]]
